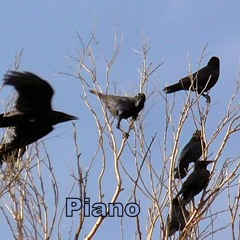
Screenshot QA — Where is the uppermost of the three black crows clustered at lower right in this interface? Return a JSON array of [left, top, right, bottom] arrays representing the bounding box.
[[174, 131, 205, 179]]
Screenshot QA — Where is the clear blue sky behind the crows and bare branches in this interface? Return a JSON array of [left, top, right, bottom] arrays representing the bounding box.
[[0, 0, 240, 239]]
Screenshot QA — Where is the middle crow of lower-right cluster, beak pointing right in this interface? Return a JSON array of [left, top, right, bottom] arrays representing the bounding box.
[[176, 161, 213, 205]]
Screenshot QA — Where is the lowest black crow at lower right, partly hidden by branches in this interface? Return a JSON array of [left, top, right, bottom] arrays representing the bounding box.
[[167, 198, 189, 236]]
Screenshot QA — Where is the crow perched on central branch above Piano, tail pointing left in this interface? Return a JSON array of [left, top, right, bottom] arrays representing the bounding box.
[[90, 90, 146, 129]]
